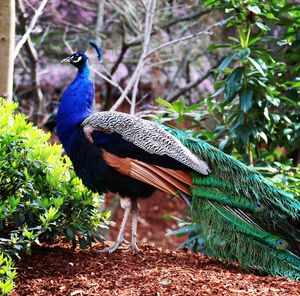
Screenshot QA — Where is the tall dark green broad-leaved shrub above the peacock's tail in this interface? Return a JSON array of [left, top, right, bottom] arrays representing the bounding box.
[[204, 0, 300, 164]]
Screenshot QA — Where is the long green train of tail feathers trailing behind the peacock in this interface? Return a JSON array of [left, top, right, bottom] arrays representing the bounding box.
[[165, 127, 300, 280]]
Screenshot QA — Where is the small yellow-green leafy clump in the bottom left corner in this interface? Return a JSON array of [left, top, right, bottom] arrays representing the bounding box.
[[0, 253, 17, 295]]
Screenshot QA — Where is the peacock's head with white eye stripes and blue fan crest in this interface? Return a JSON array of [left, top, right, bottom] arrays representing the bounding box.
[[61, 41, 102, 72]]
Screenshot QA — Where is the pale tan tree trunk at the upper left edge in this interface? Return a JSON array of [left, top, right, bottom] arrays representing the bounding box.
[[0, 0, 15, 101]]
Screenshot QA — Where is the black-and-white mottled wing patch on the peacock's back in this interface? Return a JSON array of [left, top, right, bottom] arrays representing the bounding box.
[[82, 112, 210, 175]]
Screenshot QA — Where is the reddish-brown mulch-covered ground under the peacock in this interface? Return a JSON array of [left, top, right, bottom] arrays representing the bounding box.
[[11, 195, 300, 296]]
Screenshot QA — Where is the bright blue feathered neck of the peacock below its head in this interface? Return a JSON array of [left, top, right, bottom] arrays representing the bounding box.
[[56, 63, 94, 155]]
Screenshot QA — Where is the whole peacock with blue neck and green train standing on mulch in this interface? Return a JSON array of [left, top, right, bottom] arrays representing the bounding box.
[[57, 42, 300, 280]]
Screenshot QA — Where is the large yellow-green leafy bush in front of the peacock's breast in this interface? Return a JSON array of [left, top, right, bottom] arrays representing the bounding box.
[[0, 100, 108, 256]]
